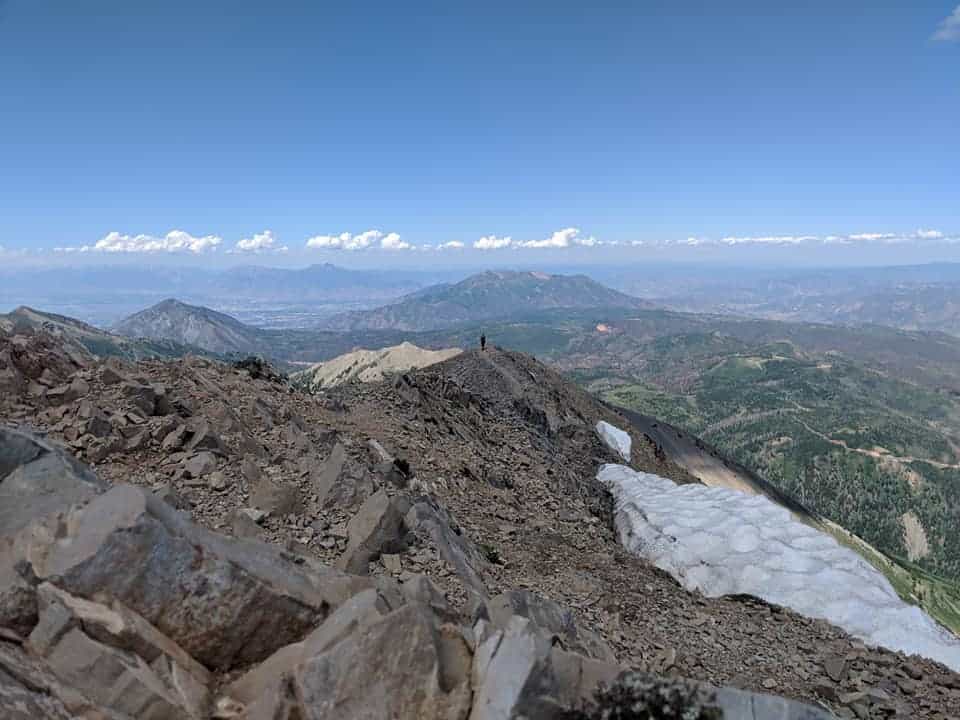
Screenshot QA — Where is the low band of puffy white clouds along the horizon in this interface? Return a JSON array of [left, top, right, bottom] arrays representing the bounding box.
[[39, 227, 960, 255]]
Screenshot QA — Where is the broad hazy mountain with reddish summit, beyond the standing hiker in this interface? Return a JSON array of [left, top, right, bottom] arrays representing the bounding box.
[[323, 271, 650, 332]]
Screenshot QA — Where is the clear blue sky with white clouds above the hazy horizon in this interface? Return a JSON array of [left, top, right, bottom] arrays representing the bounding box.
[[0, 0, 960, 265]]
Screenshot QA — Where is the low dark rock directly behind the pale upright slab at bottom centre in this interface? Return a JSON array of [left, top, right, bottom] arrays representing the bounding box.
[[487, 590, 616, 662]]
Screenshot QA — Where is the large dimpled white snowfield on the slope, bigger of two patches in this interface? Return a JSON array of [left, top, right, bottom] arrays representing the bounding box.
[[597, 464, 960, 671]]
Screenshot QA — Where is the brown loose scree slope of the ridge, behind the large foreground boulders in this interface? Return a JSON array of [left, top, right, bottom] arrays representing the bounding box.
[[0, 312, 955, 720]]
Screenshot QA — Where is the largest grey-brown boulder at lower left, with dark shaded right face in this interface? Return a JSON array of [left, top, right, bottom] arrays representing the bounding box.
[[13, 485, 372, 668]]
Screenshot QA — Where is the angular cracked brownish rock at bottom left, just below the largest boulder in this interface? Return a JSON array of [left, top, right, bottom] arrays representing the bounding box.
[[27, 583, 210, 718]]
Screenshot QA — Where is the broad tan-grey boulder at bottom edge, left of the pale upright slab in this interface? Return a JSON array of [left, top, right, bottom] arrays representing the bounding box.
[[293, 605, 470, 720]]
